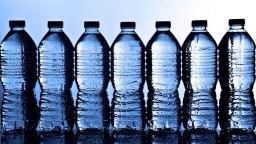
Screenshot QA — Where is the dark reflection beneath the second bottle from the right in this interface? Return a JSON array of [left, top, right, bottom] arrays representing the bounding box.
[[183, 130, 218, 144]]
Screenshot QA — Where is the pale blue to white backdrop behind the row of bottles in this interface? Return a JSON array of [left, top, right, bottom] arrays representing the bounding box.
[[0, 0, 256, 130]]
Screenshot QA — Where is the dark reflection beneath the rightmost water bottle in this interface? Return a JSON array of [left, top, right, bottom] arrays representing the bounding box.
[[219, 130, 256, 144]]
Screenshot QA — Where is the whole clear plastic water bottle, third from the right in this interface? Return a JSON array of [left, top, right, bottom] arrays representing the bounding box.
[[146, 21, 181, 131]]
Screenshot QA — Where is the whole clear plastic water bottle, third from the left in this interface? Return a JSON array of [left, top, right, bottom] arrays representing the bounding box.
[[75, 21, 110, 131]]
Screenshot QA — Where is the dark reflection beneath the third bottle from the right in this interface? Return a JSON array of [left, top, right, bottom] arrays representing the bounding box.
[[147, 131, 182, 144]]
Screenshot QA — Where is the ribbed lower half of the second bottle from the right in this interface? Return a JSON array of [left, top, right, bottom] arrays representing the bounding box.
[[182, 90, 218, 131]]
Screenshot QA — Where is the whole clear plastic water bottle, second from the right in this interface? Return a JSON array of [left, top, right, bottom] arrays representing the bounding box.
[[182, 20, 218, 131]]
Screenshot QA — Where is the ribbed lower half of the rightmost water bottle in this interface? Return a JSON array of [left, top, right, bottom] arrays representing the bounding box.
[[219, 91, 256, 133]]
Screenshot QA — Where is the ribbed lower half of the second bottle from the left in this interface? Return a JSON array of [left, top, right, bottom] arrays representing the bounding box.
[[38, 91, 74, 133]]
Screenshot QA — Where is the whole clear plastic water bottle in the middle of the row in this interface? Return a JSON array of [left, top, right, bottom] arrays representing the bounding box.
[[111, 22, 145, 131]]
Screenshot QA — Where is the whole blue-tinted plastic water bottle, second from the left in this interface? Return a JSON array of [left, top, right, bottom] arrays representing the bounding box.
[[39, 21, 74, 132]]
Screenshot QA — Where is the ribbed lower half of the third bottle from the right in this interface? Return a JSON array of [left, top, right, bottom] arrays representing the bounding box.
[[147, 91, 181, 132]]
